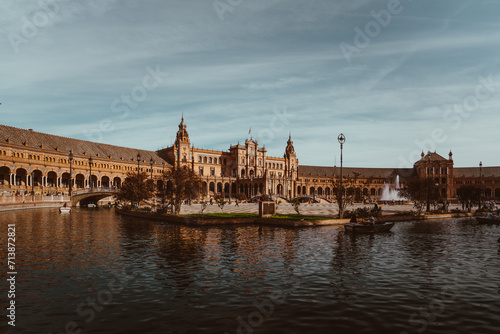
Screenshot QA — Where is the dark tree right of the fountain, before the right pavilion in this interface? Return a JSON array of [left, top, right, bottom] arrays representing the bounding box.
[[398, 176, 439, 214]]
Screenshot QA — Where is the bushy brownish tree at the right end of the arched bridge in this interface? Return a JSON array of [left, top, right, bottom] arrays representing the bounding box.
[[116, 172, 154, 203]]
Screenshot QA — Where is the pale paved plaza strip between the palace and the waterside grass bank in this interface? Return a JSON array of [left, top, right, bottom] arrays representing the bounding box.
[[181, 203, 464, 216]]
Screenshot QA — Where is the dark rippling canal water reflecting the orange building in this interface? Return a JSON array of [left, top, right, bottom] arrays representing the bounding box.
[[0, 209, 500, 334]]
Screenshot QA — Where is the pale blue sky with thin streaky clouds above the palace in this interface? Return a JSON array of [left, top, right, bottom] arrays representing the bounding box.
[[0, 0, 500, 168]]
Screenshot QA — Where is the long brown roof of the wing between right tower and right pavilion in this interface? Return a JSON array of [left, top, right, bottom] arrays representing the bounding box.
[[299, 165, 415, 178]]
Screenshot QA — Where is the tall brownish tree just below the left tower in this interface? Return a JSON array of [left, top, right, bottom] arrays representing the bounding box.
[[163, 166, 203, 215]]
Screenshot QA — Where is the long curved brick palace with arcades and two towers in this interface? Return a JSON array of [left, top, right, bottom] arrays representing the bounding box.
[[0, 117, 500, 201]]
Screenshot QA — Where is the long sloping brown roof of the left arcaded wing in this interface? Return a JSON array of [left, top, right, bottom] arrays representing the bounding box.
[[0, 125, 170, 163]]
